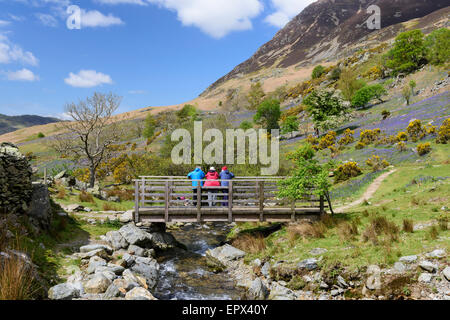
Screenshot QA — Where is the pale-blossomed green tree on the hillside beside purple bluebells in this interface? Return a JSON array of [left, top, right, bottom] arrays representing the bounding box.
[[303, 90, 349, 135]]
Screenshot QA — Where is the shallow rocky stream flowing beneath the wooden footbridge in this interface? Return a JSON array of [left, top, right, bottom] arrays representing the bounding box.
[[154, 223, 243, 300]]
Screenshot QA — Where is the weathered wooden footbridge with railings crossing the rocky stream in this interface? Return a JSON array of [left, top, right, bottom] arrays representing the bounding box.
[[134, 176, 327, 223]]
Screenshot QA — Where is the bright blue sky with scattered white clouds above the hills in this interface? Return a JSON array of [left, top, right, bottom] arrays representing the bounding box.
[[0, 0, 313, 117]]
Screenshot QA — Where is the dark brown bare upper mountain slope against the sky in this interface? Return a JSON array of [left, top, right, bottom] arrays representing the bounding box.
[[205, 0, 449, 92]]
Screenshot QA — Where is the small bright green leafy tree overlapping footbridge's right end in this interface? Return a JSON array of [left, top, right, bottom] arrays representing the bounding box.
[[277, 143, 333, 213]]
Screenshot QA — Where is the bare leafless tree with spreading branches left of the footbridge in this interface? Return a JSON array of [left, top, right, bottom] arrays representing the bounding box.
[[52, 92, 122, 188]]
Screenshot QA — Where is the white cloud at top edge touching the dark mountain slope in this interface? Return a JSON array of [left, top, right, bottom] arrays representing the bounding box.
[[265, 0, 315, 28]]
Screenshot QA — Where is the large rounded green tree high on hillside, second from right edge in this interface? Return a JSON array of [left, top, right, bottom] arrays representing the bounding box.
[[386, 30, 427, 75]]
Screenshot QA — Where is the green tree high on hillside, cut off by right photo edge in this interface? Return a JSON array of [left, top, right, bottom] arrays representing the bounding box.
[[425, 28, 450, 65]]
